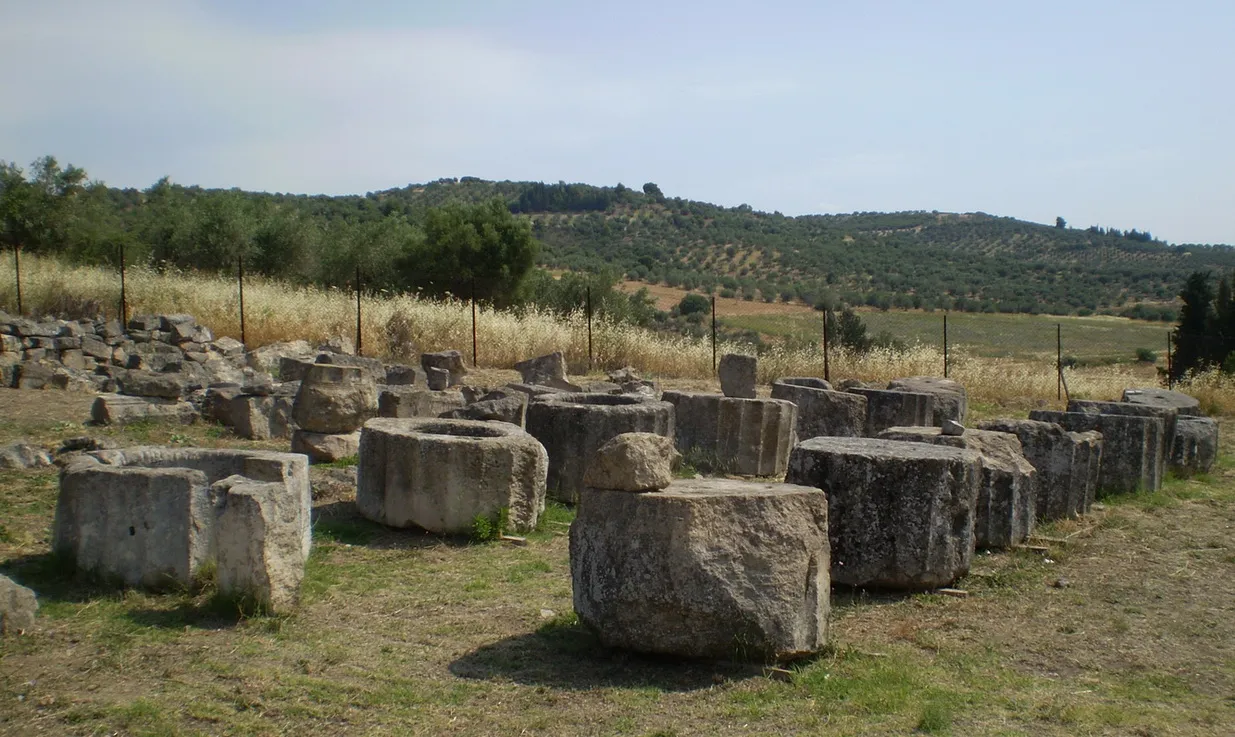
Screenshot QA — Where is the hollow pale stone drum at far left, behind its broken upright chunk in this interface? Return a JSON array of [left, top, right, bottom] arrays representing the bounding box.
[[52, 447, 312, 588]]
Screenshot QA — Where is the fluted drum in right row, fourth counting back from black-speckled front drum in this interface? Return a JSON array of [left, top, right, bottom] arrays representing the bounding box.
[[1029, 405, 1166, 494]]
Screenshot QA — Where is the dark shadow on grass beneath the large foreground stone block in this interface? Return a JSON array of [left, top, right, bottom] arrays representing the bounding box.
[[450, 623, 763, 691]]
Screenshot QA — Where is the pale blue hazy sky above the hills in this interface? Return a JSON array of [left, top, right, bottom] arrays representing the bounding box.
[[0, 0, 1235, 244]]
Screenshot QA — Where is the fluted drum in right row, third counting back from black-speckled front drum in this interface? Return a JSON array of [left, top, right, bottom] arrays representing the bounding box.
[[978, 420, 1103, 522]]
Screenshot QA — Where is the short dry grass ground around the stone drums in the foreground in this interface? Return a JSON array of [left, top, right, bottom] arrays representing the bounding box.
[[0, 381, 1235, 737]]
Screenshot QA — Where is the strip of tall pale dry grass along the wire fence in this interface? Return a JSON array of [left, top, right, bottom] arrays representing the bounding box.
[[0, 256, 1215, 411]]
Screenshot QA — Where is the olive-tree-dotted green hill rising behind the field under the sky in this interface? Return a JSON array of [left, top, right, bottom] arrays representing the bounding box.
[[369, 178, 1235, 319]]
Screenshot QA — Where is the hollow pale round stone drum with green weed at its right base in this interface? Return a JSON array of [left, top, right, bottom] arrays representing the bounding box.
[[356, 417, 548, 535]]
